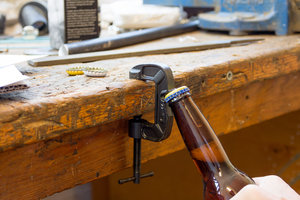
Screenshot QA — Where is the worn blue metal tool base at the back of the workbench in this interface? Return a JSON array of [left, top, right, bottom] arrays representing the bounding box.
[[144, 0, 300, 35]]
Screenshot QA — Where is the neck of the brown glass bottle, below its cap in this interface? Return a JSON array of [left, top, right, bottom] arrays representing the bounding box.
[[170, 93, 233, 178]]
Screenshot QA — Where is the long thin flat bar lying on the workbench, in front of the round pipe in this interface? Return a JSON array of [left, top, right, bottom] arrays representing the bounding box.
[[28, 38, 263, 67]]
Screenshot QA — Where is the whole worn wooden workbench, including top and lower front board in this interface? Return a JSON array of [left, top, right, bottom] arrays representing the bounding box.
[[0, 32, 300, 199]]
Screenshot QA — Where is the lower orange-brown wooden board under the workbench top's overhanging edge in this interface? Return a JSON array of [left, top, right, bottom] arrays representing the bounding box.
[[0, 72, 300, 200]]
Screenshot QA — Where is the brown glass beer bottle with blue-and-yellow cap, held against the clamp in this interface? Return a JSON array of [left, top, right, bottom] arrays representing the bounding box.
[[165, 86, 254, 200]]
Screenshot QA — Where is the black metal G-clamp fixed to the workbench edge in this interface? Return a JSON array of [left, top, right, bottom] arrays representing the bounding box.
[[119, 64, 174, 184]]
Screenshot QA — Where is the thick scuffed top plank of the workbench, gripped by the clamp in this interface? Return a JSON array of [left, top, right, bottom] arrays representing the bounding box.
[[0, 36, 300, 151]]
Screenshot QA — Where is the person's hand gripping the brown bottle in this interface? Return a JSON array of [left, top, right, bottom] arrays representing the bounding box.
[[231, 175, 300, 200]]
